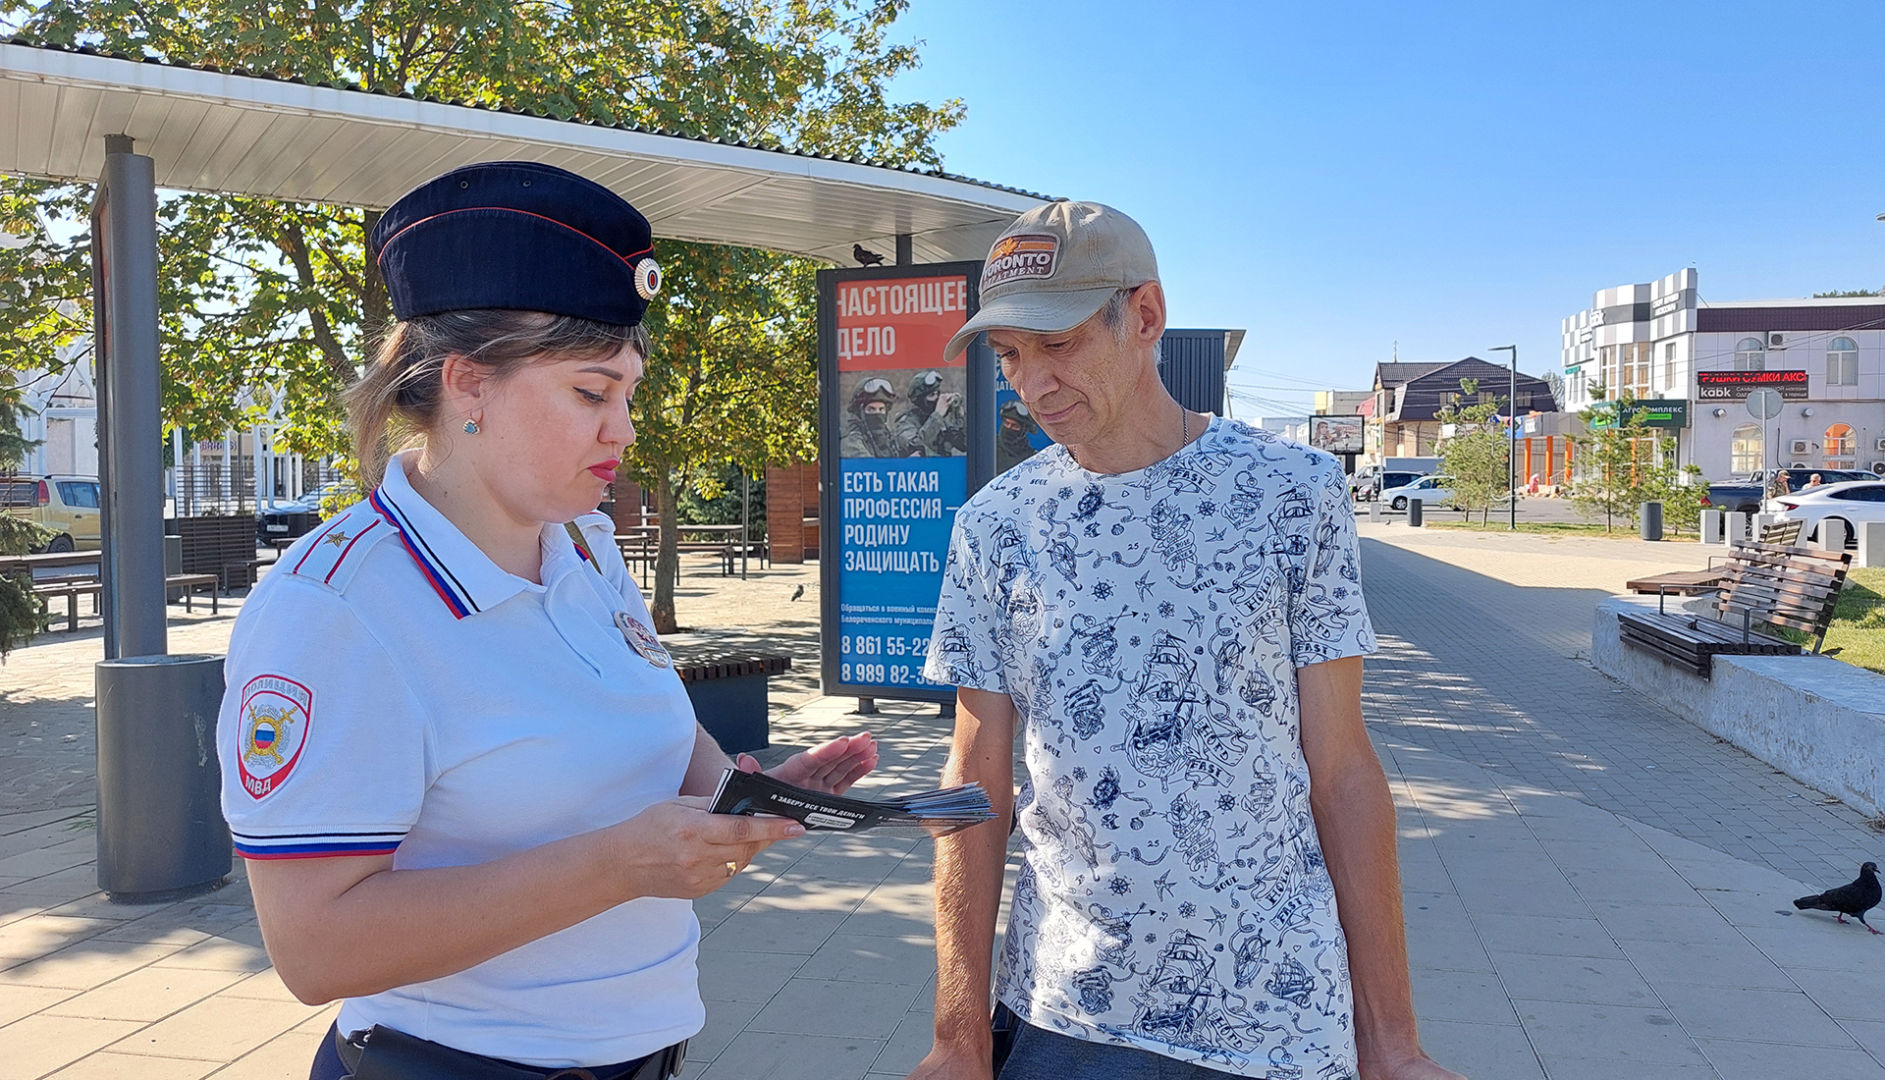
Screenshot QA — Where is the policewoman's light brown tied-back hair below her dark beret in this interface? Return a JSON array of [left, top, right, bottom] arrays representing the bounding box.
[[345, 309, 648, 488]]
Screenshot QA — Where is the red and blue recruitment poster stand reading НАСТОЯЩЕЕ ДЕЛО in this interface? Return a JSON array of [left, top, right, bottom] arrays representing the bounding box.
[[818, 262, 992, 701]]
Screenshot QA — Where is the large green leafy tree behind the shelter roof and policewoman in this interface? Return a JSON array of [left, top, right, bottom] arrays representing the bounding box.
[[0, 0, 963, 626]]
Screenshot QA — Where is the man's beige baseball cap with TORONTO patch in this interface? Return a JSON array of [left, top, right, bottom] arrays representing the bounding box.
[[943, 202, 1159, 364]]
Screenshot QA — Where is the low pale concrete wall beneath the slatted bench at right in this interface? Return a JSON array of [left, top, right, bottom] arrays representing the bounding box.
[[1591, 596, 1885, 814]]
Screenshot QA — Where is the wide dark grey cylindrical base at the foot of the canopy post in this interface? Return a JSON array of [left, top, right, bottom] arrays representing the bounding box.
[[98, 656, 230, 903]]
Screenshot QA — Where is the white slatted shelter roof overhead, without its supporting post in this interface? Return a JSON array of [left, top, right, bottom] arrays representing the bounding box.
[[0, 41, 1048, 266]]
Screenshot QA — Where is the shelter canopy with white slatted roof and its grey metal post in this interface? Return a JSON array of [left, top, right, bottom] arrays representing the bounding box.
[[0, 40, 1046, 662]]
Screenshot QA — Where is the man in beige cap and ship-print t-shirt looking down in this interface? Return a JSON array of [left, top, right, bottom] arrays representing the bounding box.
[[912, 202, 1457, 1080]]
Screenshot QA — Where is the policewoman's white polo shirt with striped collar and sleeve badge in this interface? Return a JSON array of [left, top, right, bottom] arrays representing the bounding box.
[[217, 454, 705, 1067]]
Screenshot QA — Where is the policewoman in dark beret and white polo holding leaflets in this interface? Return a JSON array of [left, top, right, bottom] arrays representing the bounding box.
[[219, 162, 877, 1080]]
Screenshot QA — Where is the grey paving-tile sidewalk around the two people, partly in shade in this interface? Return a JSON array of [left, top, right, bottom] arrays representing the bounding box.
[[0, 528, 1885, 1080]]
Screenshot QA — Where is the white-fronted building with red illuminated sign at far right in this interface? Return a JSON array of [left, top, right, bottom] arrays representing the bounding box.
[[1563, 270, 1885, 479]]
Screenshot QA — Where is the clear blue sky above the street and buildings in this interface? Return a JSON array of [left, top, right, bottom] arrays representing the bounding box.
[[897, 0, 1885, 417]]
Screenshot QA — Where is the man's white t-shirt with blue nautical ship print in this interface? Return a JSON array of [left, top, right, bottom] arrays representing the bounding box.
[[926, 418, 1374, 1080]]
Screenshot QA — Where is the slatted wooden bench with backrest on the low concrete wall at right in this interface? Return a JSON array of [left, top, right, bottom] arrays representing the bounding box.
[[1617, 543, 1851, 679]]
